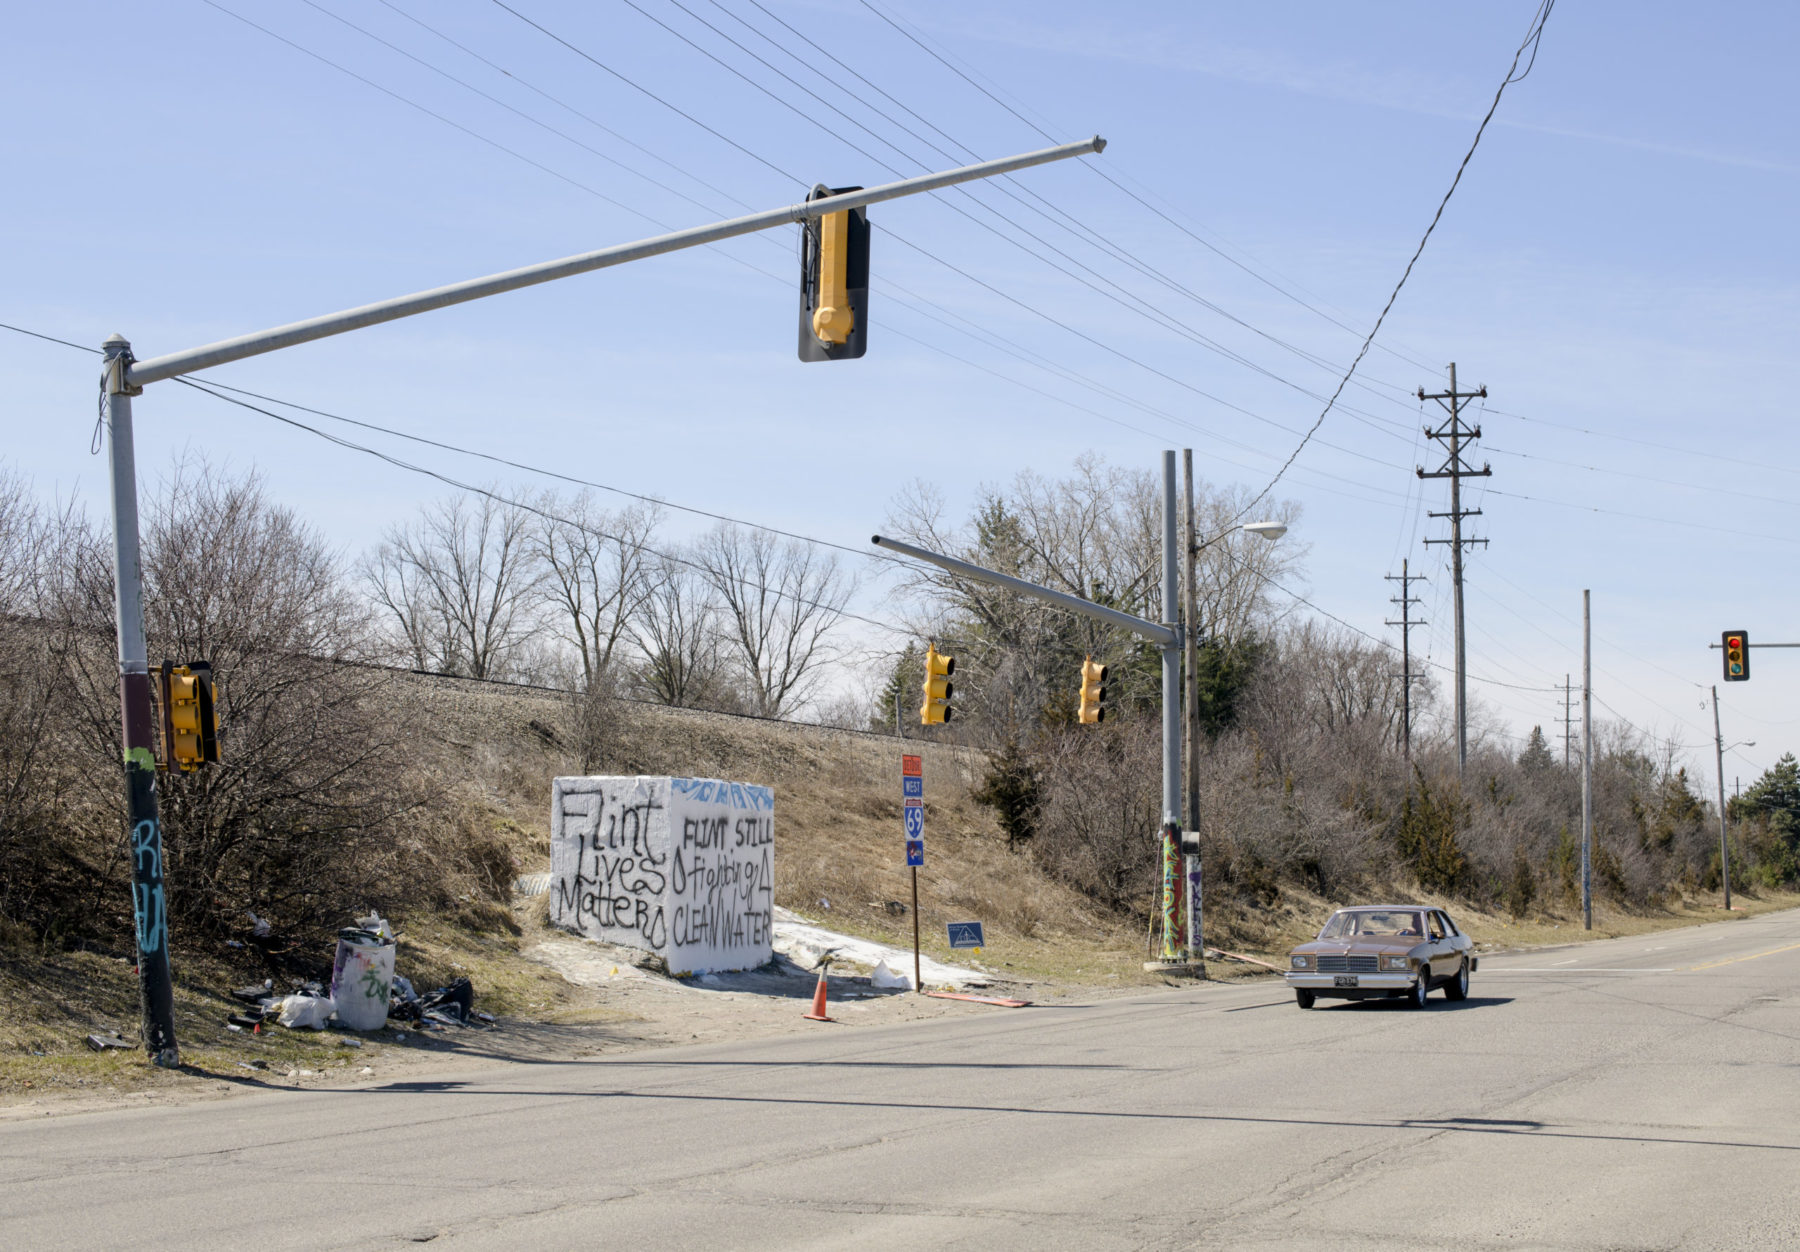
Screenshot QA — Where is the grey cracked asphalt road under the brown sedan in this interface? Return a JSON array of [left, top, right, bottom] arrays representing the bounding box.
[[0, 912, 1800, 1252]]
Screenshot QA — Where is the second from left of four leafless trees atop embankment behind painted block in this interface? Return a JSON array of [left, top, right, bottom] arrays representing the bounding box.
[[533, 491, 661, 687]]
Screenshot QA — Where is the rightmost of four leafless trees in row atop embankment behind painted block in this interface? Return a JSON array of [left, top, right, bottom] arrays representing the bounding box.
[[695, 523, 855, 718]]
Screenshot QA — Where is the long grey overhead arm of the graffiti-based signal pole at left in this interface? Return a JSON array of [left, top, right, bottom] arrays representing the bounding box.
[[128, 135, 1107, 387]]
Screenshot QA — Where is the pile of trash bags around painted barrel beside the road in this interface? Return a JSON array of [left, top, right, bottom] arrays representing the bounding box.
[[227, 914, 493, 1034]]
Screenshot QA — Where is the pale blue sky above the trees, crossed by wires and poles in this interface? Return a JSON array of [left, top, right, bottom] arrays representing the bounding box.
[[0, 0, 1800, 777]]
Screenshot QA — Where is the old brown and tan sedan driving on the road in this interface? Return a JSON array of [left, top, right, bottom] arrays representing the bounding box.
[[1287, 905, 1478, 1009]]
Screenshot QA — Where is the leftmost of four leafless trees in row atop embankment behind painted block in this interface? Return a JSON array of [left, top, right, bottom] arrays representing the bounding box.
[[364, 493, 542, 678]]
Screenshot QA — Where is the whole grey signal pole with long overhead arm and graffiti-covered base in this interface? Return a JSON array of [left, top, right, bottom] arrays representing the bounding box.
[[101, 135, 1107, 1067]]
